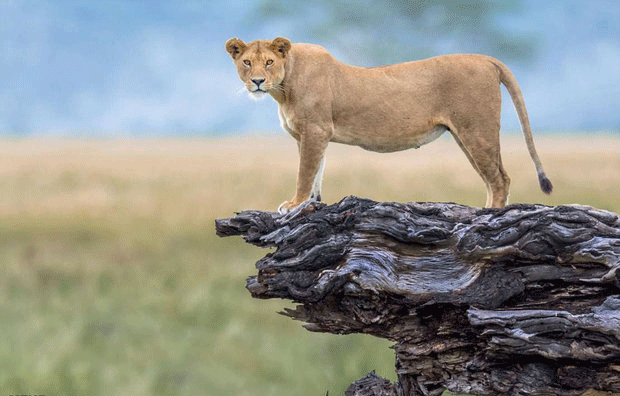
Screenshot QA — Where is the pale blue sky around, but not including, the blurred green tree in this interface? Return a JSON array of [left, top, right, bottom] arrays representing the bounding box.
[[0, 0, 620, 137]]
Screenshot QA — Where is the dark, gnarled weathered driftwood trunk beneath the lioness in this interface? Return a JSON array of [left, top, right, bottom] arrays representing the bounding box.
[[216, 197, 620, 396]]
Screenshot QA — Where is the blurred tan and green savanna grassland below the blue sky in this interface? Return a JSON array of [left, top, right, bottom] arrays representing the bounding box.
[[0, 134, 620, 396]]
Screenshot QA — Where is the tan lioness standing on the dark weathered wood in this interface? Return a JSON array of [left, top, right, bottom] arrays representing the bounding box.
[[226, 37, 553, 213]]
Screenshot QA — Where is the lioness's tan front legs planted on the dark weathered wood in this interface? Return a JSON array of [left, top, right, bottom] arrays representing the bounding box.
[[278, 129, 329, 213]]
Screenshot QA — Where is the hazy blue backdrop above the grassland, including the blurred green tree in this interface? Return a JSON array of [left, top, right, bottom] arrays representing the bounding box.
[[0, 0, 620, 137]]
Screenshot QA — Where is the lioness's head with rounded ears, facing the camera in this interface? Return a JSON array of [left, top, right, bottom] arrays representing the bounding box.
[[226, 37, 291, 97]]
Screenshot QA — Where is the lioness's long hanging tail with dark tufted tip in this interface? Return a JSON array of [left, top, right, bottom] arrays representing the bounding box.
[[493, 59, 553, 194]]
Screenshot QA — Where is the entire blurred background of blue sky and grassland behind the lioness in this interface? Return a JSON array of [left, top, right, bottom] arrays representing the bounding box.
[[0, 0, 620, 396]]
